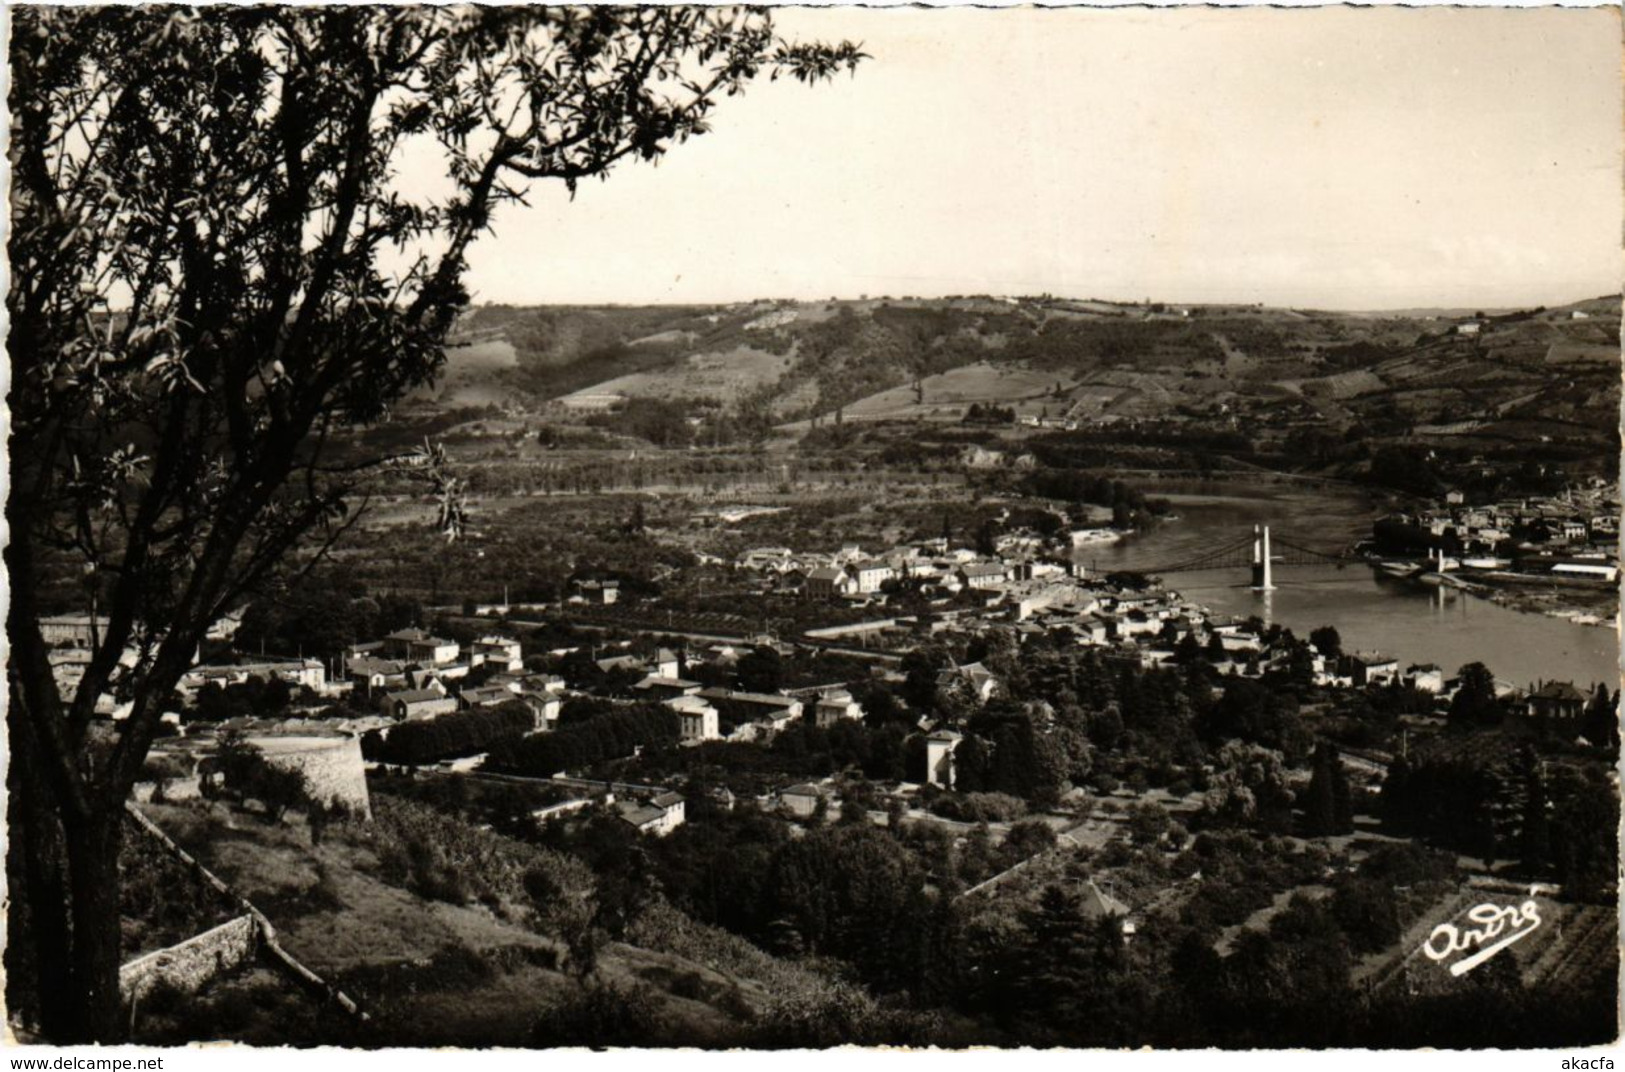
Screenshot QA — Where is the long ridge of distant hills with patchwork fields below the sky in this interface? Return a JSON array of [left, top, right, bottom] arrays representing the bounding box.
[[366, 296, 1620, 494]]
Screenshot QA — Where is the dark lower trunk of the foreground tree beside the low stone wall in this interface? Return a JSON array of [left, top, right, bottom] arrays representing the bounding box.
[[63, 804, 124, 1043]]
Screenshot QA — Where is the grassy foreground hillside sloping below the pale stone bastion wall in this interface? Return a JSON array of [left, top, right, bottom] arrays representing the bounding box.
[[137, 796, 897, 1046]]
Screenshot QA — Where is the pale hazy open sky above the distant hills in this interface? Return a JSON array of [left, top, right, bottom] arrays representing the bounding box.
[[438, 8, 1625, 309]]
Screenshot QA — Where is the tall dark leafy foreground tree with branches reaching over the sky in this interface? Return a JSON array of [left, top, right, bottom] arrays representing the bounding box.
[[5, 6, 861, 1041]]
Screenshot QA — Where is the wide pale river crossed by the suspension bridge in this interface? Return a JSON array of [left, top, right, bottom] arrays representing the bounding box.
[[1074, 482, 1620, 689]]
